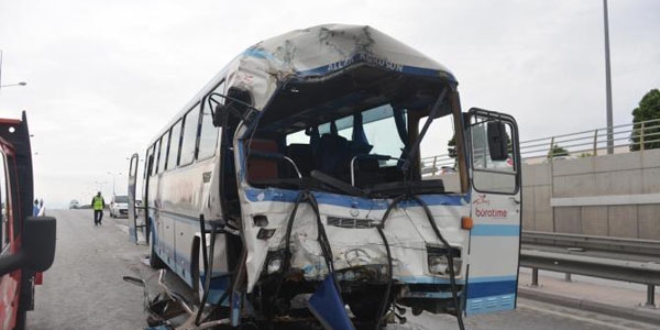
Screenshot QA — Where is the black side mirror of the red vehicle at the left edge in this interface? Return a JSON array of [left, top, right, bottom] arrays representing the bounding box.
[[0, 217, 57, 276]]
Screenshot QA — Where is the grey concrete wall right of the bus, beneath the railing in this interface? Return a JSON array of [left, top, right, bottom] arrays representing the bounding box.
[[522, 149, 660, 240]]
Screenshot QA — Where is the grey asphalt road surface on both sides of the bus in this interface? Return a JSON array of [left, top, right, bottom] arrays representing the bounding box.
[[23, 210, 660, 330]]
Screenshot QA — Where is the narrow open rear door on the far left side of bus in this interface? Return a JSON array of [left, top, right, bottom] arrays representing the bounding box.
[[128, 153, 148, 244]]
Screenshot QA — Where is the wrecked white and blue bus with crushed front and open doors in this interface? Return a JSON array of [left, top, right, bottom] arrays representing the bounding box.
[[127, 25, 521, 329]]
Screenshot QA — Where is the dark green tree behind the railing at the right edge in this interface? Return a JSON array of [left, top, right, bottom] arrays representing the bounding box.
[[630, 89, 660, 151]]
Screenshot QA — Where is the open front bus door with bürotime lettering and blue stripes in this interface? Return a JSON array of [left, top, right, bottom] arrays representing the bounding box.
[[464, 108, 522, 315]]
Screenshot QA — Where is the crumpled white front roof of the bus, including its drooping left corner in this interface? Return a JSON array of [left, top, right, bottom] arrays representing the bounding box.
[[222, 24, 456, 109]]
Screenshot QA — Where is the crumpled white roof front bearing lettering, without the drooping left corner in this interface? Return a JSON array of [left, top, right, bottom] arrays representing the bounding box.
[[241, 24, 455, 81]]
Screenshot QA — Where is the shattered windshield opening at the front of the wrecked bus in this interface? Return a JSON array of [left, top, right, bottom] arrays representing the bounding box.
[[246, 67, 453, 196]]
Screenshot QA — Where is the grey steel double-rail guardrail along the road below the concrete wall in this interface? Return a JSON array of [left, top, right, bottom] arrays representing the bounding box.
[[520, 231, 660, 307]]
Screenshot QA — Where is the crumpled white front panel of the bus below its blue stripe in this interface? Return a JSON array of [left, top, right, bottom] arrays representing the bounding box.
[[240, 188, 469, 285]]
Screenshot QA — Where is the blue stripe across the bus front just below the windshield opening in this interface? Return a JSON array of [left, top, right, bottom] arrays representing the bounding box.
[[245, 188, 467, 210]]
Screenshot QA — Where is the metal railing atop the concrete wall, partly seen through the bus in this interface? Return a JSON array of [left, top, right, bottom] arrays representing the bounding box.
[[421, 119, 660, 175]]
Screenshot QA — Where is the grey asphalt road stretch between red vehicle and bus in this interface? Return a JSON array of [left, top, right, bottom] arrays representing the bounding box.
[[28, 210, 157, 330]]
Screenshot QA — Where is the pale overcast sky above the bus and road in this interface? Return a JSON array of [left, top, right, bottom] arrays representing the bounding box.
[[0, 0, 660, 207]]
